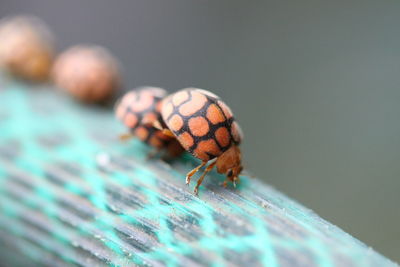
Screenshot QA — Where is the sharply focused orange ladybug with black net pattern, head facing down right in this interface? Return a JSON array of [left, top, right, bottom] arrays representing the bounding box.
[[161, 88, 243, 194]]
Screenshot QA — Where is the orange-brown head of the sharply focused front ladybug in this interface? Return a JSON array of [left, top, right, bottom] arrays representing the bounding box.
[[217, 145, 243, 184]]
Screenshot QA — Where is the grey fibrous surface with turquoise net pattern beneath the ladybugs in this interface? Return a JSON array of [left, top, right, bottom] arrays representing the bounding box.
[[0, 76, 395, 266]]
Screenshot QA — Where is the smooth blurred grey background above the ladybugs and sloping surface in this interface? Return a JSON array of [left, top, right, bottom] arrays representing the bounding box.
[[0, 0, 400, 261]]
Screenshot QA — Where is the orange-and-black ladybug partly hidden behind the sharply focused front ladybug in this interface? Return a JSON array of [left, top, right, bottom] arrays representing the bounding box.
[[115, 87, 184, 157]]
